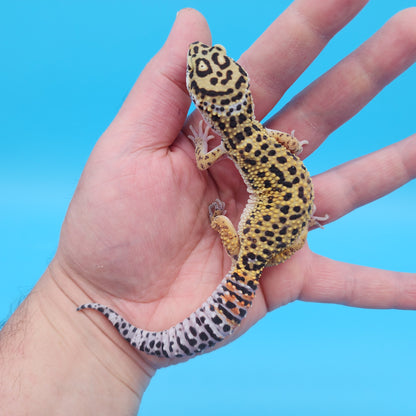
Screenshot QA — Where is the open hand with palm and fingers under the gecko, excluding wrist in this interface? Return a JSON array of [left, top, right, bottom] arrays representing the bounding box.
[[57, 0, 416, 366]]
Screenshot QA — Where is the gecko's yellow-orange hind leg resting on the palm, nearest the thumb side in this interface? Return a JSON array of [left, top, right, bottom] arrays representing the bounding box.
[[208, 199, 240, 259]]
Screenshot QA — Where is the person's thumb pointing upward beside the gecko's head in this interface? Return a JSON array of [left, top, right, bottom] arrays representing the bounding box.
[[115, 8, 211, 149]]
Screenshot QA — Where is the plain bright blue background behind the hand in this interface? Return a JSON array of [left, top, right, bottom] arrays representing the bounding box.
[[0, 0, 416, 416]]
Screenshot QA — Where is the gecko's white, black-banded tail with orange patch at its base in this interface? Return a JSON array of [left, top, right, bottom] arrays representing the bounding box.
[[77, 272, 254, 358]]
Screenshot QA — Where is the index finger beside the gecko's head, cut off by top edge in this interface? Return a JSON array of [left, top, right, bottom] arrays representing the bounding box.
[[239, 0, 368, 120]]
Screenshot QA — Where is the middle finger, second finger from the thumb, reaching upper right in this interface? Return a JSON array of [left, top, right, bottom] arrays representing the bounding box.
[[268, 9, 416, 158]]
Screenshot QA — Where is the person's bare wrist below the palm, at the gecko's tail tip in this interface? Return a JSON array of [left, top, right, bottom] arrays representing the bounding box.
[[0, 261, 154, 415]]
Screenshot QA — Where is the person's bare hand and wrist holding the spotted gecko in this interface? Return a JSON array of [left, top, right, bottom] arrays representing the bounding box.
[[0, 0, 416, 415]]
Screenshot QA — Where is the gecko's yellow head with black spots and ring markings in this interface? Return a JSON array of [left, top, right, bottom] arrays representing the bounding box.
[[186, 42, 253, 118]]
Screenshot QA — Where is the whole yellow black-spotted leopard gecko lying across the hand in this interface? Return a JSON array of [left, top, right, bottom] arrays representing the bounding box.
[[79, 42, 324, 357]]
